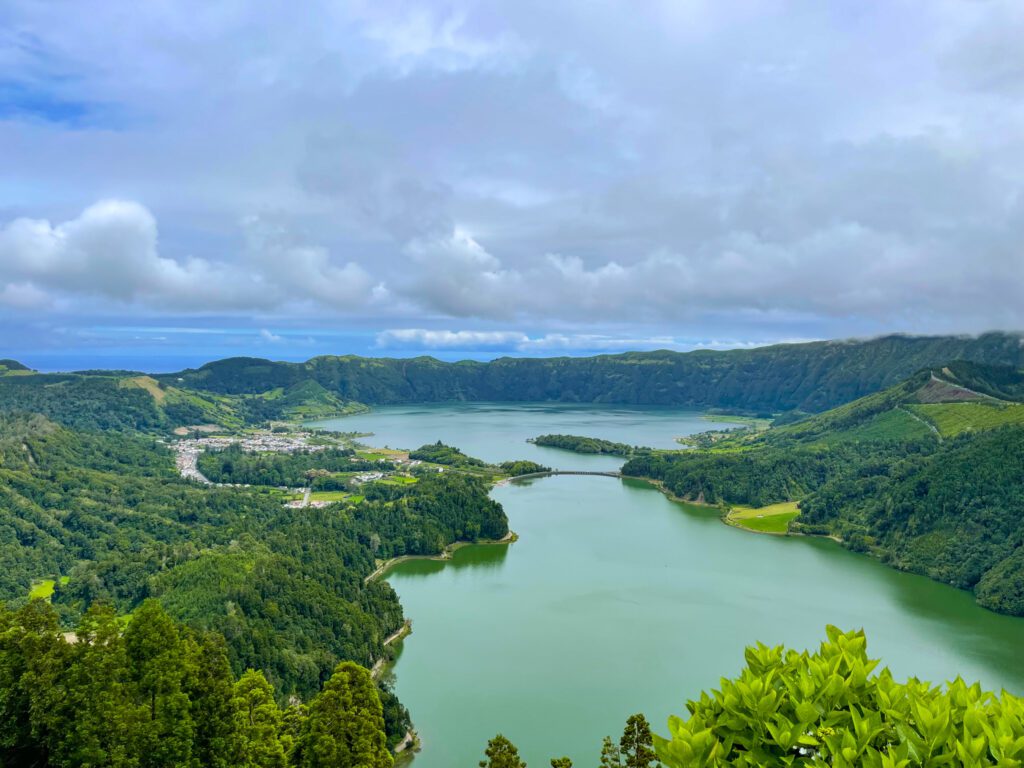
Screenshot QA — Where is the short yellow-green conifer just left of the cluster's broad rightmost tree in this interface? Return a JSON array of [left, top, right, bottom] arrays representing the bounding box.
[[229, 670, 288, 768]]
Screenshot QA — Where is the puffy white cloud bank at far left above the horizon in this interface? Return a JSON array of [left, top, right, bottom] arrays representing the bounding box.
[[0, 200, 374, 311]]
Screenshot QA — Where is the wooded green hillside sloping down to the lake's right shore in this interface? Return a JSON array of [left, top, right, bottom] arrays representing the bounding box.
[[623, 361, 1024, 615]]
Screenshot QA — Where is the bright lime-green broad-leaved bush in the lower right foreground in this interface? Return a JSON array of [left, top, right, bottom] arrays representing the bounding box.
[[654, 627, 1024, 768]]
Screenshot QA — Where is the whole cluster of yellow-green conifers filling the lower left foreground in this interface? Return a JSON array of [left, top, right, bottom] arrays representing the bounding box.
[[0, 600, 393, 768]]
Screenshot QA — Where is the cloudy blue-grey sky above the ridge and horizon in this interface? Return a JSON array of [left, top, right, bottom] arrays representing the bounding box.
[[0, 0, 1024, 371]]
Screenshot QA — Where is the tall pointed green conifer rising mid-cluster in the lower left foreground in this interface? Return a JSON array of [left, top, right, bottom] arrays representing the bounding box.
[[125, 600, 196, 768]]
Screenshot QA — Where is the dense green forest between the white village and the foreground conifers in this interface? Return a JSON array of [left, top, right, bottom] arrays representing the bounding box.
[[0, 416, 508, 697]]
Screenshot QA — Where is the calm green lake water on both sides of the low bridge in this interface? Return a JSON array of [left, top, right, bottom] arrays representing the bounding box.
[[311, 403, 1024, 768]]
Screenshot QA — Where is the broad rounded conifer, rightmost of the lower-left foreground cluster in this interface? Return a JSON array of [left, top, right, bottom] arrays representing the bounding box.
[[298, 662, 394, 768]]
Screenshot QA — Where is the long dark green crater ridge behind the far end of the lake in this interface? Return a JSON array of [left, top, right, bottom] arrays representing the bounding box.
[[155, 333, 1024, 413]]
